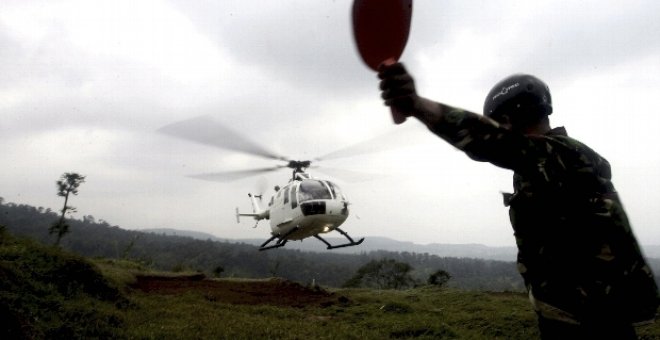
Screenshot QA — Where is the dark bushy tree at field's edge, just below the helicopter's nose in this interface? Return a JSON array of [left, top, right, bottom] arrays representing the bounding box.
[[344, 259, 415, 289]]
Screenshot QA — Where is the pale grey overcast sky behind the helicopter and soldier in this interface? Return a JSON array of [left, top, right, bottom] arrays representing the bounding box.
[[0, 0, 660, 247]]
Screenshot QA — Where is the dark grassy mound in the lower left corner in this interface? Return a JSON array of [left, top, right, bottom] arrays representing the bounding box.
[[0, 227, 128, 339]]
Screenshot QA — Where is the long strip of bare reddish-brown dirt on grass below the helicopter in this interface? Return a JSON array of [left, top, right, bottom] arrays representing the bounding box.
[[132, 274, 348, 307]]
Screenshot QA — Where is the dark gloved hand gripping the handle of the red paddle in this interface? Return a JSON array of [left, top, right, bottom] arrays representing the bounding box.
[[378, 63, 420, 117]]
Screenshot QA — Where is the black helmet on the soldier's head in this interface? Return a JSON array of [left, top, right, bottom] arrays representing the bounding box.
[[484, 74, 552, 121]]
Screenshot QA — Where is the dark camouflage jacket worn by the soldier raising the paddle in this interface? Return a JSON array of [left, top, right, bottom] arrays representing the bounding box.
[[430, 110, 660, 322]]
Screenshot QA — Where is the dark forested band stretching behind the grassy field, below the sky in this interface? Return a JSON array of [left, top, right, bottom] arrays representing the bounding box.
[[0, 201, 660, 291]]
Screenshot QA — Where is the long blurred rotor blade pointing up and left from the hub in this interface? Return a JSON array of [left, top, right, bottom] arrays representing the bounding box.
[[158, 116, 288, 161]]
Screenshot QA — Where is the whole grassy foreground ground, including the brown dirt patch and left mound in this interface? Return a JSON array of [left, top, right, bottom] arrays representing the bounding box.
[[0, 228, 660, 339]]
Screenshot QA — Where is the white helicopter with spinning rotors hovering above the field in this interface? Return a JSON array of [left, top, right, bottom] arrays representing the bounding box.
[[158, 116, 376, 251]]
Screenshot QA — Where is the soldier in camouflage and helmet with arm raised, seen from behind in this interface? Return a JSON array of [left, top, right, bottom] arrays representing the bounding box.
[[379, 63, 660, 339]]
